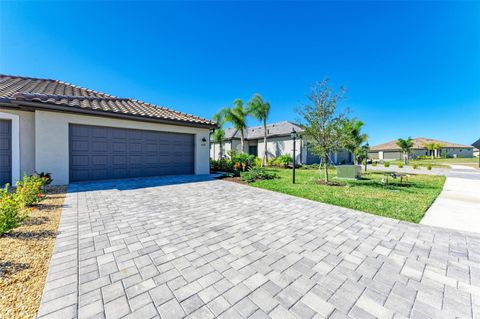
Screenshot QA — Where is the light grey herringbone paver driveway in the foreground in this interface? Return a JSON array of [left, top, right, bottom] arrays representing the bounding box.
[[39, 177, 480, 319]]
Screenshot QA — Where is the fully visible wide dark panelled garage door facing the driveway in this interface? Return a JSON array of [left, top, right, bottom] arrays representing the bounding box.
[[69, 124, 194, 182]]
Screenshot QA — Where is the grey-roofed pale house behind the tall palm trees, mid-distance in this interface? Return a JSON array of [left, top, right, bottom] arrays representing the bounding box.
[[210, 121, 353, 164]]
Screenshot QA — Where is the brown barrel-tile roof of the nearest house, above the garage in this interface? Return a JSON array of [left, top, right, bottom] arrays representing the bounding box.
[[0, 74, 215, 127]]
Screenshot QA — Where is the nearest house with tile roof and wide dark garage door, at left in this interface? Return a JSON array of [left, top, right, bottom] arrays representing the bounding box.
[[0, 75, 216, 185]]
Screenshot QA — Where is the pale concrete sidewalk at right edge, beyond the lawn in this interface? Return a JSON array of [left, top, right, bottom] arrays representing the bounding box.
[[420, 165, 480, 233]]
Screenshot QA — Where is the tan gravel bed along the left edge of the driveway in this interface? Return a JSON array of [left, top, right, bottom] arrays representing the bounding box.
[[0, 186, 66, 318]]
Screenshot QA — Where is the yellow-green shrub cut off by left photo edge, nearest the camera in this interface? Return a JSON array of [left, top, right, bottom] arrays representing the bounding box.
[[0, 185, 27, 234]]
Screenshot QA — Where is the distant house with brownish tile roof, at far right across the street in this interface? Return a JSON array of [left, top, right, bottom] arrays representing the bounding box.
[[368, 137, 473, 160]]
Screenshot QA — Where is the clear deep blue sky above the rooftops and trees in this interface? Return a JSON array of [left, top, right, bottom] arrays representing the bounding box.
[[0, 2, 480, 145]]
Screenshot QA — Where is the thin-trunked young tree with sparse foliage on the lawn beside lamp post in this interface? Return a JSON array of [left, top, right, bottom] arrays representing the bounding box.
[[297, 80, 349, 183]]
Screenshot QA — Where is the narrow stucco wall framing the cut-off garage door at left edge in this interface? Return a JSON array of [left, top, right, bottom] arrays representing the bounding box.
[[0, 108, 35, 182]]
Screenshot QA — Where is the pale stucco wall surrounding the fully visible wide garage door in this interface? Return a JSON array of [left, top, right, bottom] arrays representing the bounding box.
[[35, 110, 210, 184]]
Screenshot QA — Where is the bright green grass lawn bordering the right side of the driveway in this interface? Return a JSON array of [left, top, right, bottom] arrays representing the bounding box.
[[250, 169, 445, 223]]
